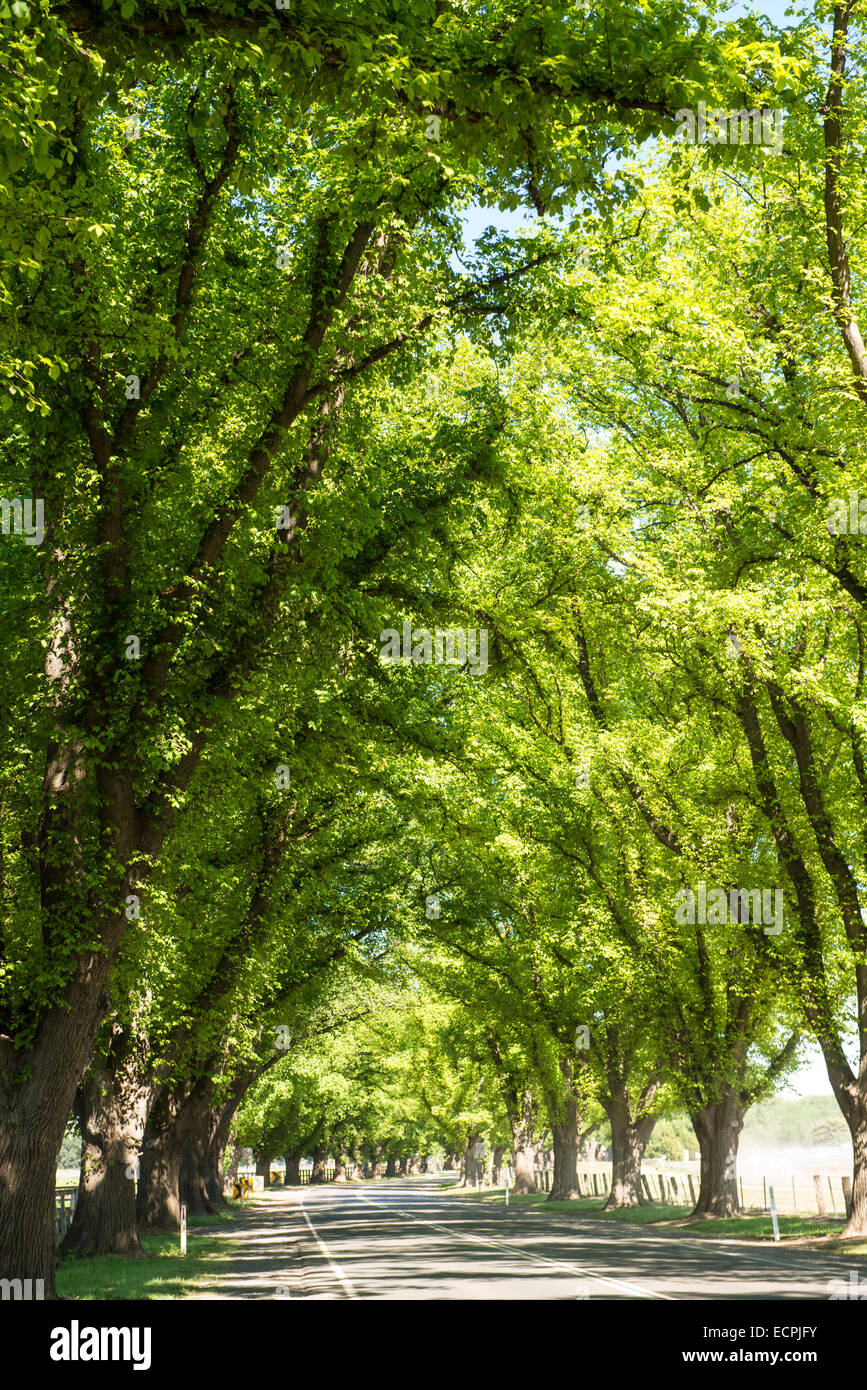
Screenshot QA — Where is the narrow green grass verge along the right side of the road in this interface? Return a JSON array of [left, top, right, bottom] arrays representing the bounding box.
[[445, 1187, 867, 1255]]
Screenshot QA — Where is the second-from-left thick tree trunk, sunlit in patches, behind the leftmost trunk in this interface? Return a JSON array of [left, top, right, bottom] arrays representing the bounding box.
[[61, 1026, 150, 1255]]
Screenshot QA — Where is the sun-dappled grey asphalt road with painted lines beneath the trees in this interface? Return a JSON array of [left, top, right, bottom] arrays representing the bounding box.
[[193, 1179, 864, 1302]]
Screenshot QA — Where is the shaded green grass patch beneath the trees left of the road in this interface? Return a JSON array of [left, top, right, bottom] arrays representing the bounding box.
[[57, 1204, 238, 1300]]
